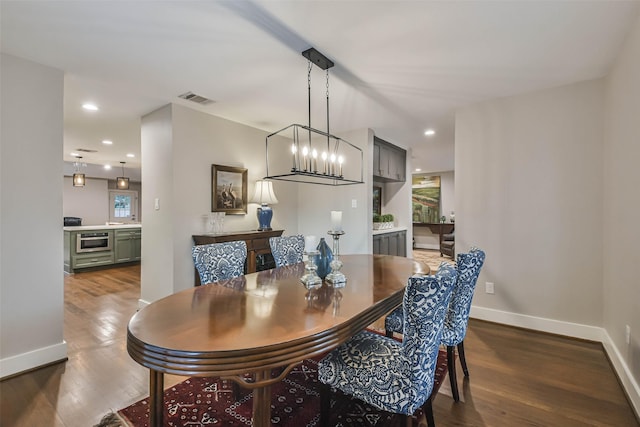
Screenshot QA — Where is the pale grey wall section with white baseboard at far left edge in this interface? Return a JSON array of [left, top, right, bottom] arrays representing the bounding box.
[[0, 54, 67, 377]]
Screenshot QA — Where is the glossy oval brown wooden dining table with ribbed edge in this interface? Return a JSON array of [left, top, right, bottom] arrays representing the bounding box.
[[127, 255, 429, 427]]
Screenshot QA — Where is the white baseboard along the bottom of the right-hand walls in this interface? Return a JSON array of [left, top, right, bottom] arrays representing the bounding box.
[[470, 306, 640, 416]]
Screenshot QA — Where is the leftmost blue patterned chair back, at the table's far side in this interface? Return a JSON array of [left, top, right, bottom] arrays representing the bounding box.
[[192, 241, 247, 285]]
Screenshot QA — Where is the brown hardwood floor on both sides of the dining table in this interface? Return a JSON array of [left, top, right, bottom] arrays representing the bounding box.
[[0, 266, 640, 427]]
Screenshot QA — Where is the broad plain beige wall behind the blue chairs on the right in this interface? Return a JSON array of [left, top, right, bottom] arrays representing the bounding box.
[[455, 80, 604, 328]]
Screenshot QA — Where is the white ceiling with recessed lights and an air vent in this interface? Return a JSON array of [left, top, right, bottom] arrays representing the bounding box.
[[0, 0, 640, 176]]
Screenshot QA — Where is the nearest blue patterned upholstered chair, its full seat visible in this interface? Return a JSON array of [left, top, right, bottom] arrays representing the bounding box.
[[318, 266, 456, 427]]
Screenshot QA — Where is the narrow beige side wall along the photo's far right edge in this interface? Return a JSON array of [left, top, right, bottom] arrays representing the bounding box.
[[602, 11, 640, 412]]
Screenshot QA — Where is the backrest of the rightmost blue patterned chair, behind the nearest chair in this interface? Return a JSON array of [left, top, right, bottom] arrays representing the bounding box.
[[442, 248, 485, 346]]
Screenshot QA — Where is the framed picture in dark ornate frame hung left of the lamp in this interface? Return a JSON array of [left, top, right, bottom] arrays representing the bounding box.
[[211, 165, 247, 215]]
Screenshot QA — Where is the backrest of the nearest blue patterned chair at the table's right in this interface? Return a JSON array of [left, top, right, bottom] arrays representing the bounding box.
[[402, 264, 457, 413]]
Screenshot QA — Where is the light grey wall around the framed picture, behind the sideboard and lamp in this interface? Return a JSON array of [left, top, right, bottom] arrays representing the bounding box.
[[141, 105, 298, 302]]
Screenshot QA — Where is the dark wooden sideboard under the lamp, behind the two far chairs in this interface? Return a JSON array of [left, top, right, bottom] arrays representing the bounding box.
[[192, 230, 284, 286]]
